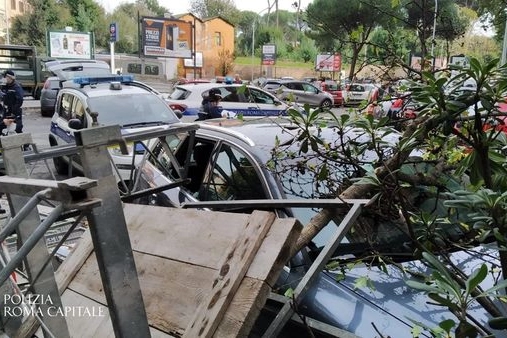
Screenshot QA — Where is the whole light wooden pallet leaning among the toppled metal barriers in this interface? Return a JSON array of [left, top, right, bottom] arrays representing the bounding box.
[[26, 204, 301, 338]]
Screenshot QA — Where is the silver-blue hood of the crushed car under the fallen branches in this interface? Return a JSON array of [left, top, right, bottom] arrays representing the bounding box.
[[283, 247, 507, 337]]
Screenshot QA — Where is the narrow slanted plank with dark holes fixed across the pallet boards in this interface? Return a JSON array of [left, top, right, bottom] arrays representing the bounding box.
[[183, 211, 275, 338]]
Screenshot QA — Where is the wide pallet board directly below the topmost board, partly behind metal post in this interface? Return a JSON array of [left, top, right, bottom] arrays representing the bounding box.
[[69, 252, 216, 334]]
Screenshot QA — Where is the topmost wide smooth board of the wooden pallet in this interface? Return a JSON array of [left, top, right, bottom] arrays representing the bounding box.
[[124, 204, 249, 268]]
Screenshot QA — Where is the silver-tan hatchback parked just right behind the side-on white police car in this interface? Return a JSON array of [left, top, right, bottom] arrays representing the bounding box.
[[264, 80, 334, 108]]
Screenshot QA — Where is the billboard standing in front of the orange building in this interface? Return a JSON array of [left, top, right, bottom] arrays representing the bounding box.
[[141, 17, 192, 58]]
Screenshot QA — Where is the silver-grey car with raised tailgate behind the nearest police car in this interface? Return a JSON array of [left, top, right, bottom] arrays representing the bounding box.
[[40, 60, 111, 116]]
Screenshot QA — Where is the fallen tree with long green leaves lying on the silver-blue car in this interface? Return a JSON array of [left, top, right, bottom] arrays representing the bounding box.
[[278, 59, 507, 337]]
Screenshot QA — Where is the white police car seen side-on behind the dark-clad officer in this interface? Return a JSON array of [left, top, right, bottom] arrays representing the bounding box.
[[167, 83, 288, 116]]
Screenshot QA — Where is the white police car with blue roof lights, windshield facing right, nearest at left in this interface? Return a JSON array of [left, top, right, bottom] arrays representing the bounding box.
[[49, 76, 180, 180]]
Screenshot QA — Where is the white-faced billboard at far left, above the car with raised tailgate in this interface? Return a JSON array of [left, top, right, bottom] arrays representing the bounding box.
[[48, 31, 93, 59]]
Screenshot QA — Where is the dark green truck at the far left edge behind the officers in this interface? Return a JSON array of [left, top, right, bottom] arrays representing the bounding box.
[[0, 45, 54, 100]]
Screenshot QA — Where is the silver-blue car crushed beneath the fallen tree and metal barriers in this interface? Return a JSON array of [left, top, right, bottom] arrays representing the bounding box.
[[131, 118, 506, 337]]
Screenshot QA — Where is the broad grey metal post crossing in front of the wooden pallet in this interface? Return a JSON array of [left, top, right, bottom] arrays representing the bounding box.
[[75, 126, 151, 338]]
